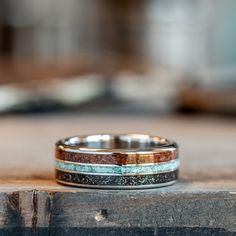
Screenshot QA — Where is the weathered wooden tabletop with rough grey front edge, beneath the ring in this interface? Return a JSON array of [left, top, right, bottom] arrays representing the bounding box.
[[0, 114, 236, 235]]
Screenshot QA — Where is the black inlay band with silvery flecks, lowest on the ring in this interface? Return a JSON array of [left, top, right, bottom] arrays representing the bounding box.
[[56, 170, 178, 186]]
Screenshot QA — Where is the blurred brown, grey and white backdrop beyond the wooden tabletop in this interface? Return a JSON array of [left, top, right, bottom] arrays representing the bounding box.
[[0, 0, 236, 115]]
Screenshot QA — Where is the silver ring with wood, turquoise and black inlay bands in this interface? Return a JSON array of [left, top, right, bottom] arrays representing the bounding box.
[[55, 134, 180, 189]]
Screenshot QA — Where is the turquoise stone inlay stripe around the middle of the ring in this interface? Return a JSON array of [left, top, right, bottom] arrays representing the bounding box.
[[55, 159, 179, 174]]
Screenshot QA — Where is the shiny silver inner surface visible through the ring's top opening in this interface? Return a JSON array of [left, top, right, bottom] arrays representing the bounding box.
[[63, 134, 171, 150]]
